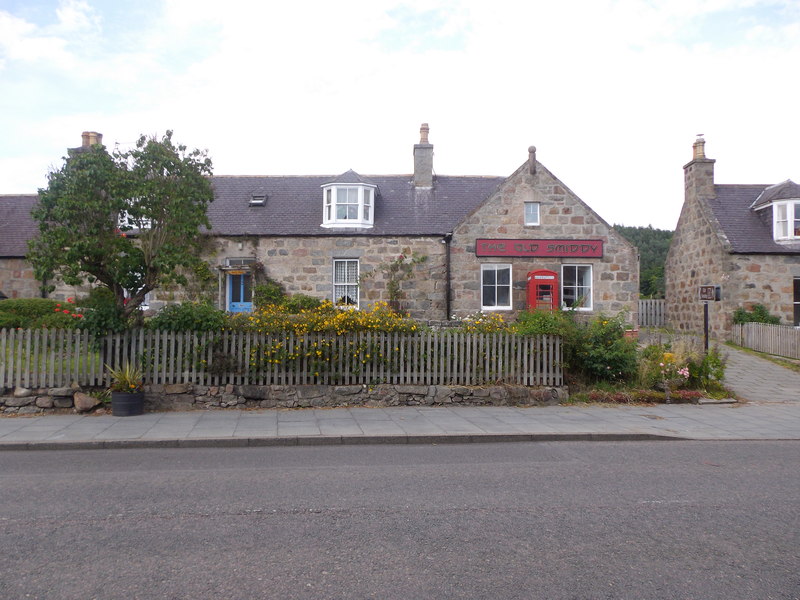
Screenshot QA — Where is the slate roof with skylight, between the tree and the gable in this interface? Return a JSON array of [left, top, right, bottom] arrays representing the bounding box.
[[208, 171, 506, 236]]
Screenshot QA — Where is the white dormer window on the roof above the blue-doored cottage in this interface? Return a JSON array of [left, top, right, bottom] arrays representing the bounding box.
[[322, 171, 377, 229]]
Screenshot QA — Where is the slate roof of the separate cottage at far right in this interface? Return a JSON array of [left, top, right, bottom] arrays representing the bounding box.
[[708, 185, 800, 254]]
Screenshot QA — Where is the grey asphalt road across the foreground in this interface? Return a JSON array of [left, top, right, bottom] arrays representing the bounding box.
[[0, 441, 800, 600]]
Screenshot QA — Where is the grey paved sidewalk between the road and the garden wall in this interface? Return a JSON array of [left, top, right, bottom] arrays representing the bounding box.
[[0, 338, 800, 450]]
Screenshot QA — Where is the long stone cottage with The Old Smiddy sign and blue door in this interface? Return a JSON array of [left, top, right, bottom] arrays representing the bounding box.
[[3, 124, 639, 324]]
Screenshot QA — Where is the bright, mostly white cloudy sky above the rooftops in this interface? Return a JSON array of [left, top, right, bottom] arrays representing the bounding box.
[[0, 0, 800, 229]]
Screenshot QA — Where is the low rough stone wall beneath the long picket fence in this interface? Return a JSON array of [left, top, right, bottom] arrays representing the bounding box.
[[0, 384, 567, 415]]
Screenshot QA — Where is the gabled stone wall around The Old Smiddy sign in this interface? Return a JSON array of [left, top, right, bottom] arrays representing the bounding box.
[[452, 163, 639, 326]]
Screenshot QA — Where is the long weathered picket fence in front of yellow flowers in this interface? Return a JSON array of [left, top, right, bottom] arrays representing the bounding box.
[[0, 329, 563, 388]]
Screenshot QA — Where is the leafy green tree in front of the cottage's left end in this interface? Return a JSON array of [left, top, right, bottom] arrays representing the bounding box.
[[28, 131, 213, 319]]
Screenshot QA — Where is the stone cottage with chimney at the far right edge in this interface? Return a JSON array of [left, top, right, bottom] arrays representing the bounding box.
[[665, 137, 800, 338]]
